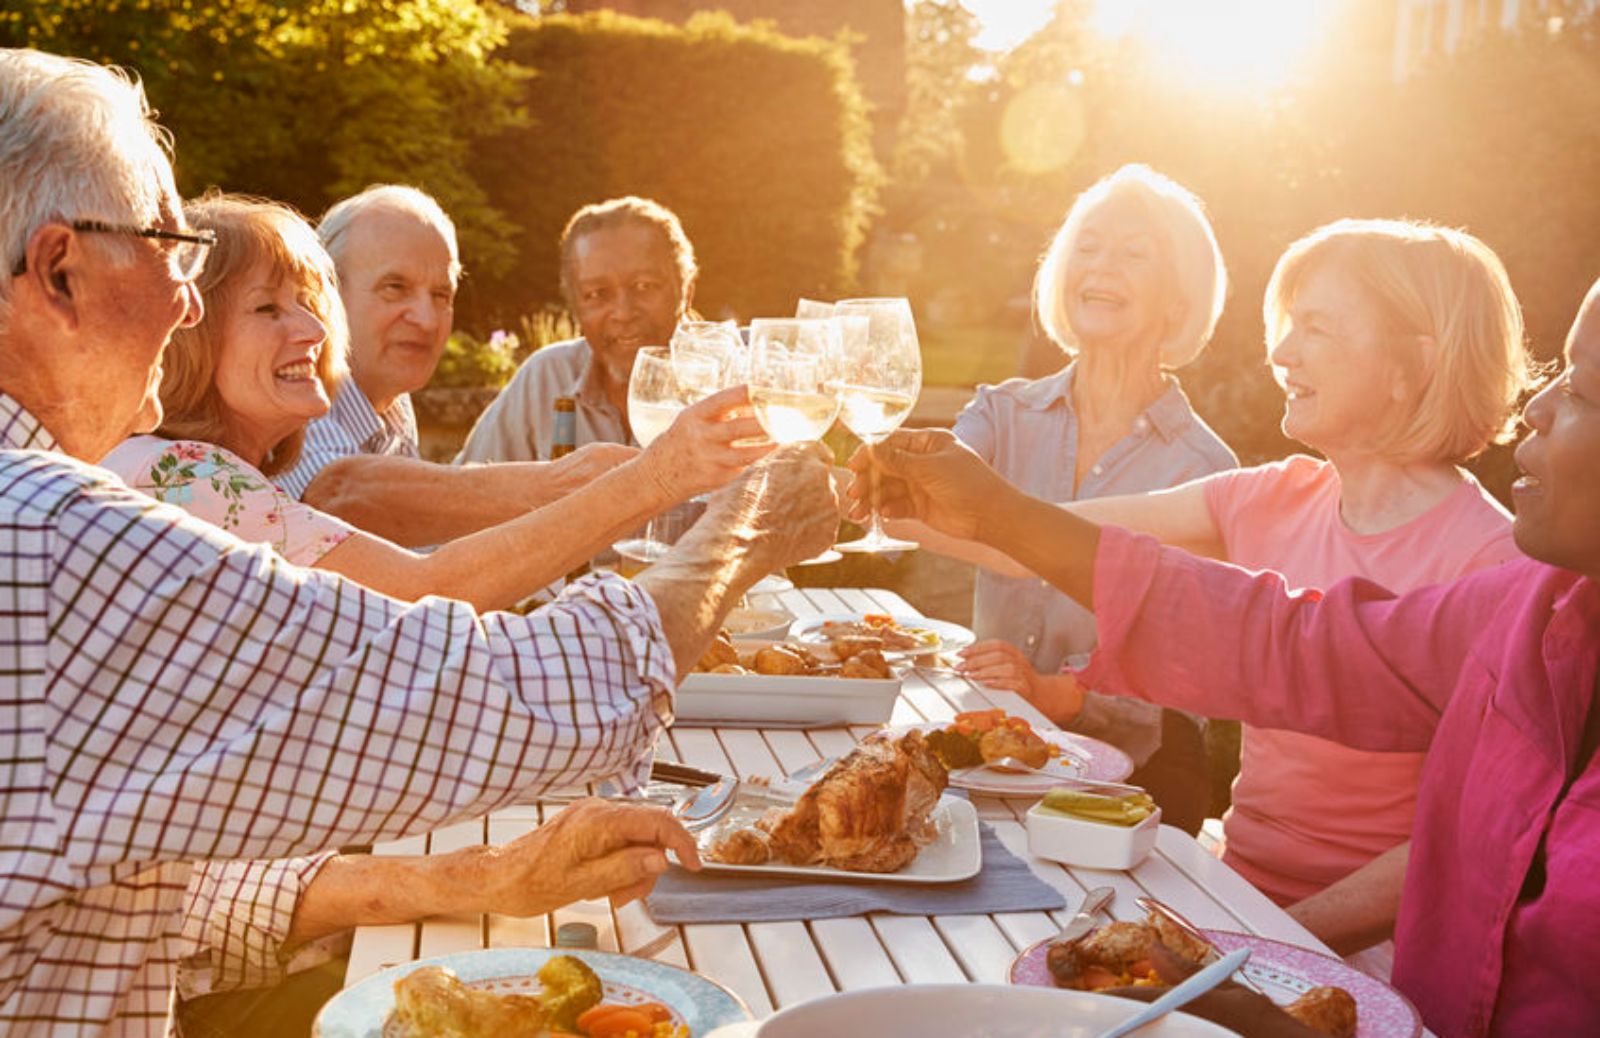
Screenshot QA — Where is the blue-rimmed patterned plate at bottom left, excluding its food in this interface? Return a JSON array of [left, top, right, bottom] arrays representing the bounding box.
[[312, 948, 750, 1038]]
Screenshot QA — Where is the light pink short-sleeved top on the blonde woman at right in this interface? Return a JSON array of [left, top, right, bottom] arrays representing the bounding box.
[[1205, 456, 1520, 904]]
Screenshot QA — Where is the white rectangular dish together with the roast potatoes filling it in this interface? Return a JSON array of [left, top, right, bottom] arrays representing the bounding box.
[[672, 632, 902, 728]]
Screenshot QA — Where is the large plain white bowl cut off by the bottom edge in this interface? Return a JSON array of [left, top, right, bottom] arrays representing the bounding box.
[[709, 984, 1234, 1038]]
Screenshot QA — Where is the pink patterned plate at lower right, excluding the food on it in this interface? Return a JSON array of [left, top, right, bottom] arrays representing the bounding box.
[[1008, 929, 1422, 1038]]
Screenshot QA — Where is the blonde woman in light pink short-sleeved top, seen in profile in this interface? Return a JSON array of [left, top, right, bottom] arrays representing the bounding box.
[[915, 221, 1530, 952]]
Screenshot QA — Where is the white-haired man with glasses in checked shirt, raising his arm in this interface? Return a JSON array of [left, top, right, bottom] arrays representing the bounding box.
[[0, 51, 837, 1035]]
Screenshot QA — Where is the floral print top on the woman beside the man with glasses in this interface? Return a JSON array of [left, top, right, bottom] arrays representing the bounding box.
[[101, 437, 355, 566]]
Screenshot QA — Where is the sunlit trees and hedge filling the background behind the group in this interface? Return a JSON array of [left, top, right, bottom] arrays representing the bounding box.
[[0, 0, 1600, 491]]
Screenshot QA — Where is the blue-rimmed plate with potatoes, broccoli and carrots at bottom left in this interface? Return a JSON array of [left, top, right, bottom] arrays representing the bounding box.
[[312, 948, 750, 1038]]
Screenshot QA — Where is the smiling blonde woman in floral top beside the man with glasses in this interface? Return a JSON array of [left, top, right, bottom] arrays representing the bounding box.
[[102, 195, 770, 609]]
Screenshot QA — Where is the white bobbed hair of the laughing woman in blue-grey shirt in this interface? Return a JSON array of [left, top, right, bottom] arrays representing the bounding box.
[[1034, 163, 1227, 368]]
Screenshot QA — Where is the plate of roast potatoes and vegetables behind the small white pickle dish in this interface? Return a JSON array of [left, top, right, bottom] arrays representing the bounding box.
[[894, 709, 1133, 796]]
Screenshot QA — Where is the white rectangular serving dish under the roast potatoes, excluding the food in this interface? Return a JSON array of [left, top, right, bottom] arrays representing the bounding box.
[[672, 640, 901, 728]]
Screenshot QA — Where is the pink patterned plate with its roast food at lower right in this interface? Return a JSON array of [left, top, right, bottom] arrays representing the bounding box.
[[1010, 913, 1422, 1038]]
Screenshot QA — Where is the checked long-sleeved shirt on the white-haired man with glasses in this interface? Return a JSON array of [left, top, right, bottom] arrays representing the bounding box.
[[0, 395, 674, 1036]]
